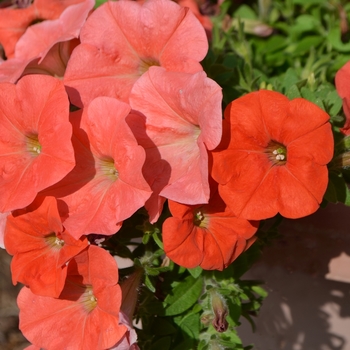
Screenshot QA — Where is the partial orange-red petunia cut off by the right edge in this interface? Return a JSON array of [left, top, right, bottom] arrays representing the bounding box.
[[335, 62, 350, 135]]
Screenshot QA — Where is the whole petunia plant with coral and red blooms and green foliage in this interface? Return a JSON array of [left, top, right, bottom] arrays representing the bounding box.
[[0, 0, 350, 350]]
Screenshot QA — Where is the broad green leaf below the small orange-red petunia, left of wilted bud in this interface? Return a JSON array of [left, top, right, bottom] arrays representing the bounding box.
[[164, 276, 203, 316]]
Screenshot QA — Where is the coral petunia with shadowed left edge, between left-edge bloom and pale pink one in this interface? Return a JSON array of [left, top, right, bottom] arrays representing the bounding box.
[[42, 97, 151, 238]]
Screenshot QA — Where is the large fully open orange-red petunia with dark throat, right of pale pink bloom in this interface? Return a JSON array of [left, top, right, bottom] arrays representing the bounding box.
[[212, 90, 334, 220]]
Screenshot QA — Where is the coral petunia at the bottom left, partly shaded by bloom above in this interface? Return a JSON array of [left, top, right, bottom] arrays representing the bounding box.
[[17, 246, 127, 350]]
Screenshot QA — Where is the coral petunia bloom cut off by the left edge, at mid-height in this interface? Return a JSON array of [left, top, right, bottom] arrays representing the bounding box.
[[0, 75, 75, 212]]
